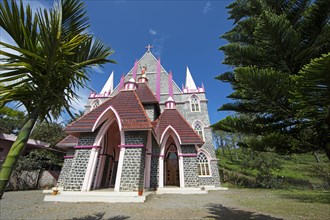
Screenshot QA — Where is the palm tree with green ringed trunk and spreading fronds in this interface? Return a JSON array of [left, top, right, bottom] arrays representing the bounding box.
[[0, 0, 114, 198]]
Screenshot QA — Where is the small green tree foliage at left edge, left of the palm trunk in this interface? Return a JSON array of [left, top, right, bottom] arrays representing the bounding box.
[[0, 106, 24, 134]]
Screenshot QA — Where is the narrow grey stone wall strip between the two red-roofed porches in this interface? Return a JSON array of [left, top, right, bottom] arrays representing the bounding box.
[[150, 138, 160, 188]]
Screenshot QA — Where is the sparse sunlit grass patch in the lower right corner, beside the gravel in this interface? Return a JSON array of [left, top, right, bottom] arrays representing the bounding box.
[[219, 189, 330, 219]]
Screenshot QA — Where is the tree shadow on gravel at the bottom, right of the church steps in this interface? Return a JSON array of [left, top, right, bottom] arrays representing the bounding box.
[[205, 203, 281, 220]]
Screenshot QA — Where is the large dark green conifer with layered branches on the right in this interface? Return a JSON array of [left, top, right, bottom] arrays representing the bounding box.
[[213, 0, 330, 159]]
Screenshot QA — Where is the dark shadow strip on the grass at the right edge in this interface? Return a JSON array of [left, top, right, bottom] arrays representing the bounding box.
[[280, 191, 330, 204]]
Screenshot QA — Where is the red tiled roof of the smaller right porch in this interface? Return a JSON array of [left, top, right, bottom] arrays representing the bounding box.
[[156, 109, 204, 144]]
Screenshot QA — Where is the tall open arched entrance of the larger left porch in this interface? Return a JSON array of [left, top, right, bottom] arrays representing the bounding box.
[[93, 120, 120, 189]]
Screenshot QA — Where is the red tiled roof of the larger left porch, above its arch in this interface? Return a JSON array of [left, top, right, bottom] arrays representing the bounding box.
[[65, 90, 152, 133]]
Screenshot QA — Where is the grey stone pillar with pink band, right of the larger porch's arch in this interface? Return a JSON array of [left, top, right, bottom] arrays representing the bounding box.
[[120, 131, 147, 191]]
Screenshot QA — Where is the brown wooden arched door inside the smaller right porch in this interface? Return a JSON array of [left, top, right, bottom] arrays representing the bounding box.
[[164, 143, 180, 186]]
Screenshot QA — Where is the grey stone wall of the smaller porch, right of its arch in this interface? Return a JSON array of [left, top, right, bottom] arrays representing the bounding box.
[[181, 145, 198, 187]]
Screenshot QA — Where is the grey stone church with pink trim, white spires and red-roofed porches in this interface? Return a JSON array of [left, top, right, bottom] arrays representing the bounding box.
[[57, 45, 220, 192]]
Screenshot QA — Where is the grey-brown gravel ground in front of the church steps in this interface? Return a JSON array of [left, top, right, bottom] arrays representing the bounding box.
[[0, 190, 284, 220]]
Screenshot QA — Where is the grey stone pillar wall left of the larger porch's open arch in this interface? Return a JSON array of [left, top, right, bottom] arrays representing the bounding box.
[[64, 149, 91, 191]]
